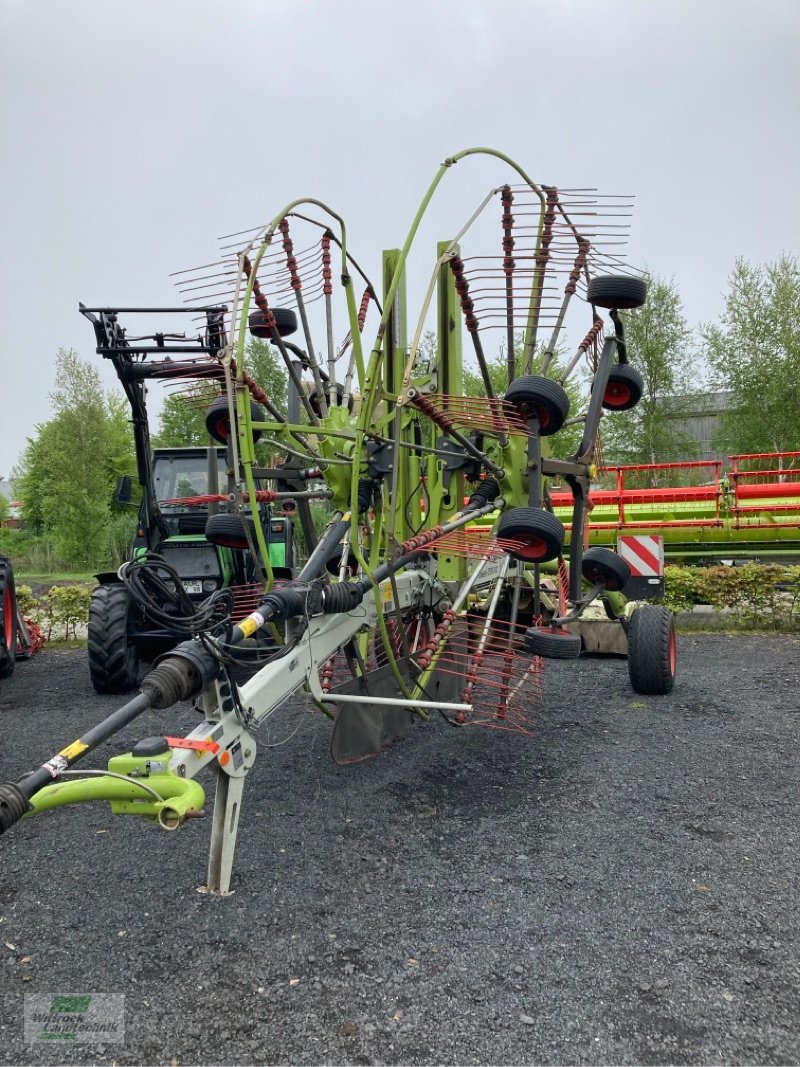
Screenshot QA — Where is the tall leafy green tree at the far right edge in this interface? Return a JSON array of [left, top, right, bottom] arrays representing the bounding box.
[[702, 256, 800, 452]]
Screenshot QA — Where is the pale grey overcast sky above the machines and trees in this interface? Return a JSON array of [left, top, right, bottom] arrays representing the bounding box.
[[0, 0, 800, 476]]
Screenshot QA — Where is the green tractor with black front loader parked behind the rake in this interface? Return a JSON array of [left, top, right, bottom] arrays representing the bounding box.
[[80, 305, 293, 694]]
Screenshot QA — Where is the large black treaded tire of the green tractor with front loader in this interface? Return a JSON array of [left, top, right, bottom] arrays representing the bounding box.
[[87, 585, 139, 692]]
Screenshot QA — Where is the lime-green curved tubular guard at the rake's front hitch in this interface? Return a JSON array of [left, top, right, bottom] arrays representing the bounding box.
[[26, 774, 206, 830]]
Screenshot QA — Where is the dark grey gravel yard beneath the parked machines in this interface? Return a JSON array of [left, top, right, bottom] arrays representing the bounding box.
[[0, 635, 800, 1064]]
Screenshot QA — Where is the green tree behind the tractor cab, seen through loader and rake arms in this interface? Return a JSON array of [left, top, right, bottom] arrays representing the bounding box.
[[153, 337, 288, 448]]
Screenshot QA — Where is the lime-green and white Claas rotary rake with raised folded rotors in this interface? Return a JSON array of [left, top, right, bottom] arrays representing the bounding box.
[[0, 148, 675, 894]]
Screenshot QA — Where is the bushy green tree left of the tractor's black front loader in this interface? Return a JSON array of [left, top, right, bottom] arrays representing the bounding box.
[[15, 348, 133, 566]]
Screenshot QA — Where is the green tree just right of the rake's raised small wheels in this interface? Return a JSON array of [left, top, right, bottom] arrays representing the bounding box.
[[601, 277, 702, 485]]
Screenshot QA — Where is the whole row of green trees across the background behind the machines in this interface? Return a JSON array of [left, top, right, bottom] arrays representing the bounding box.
[[0, 255, 800, 569]]
